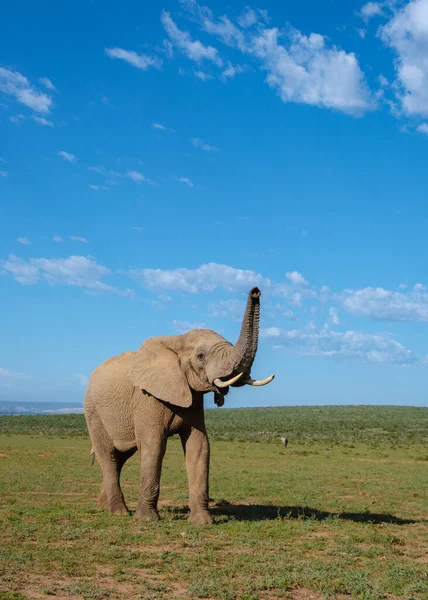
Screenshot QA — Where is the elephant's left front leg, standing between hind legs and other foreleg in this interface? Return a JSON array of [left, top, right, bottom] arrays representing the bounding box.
[[134, 434, 166, 521]]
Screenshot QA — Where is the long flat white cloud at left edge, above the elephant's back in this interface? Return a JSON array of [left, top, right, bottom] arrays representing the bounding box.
[[0, 254, 134, 296]]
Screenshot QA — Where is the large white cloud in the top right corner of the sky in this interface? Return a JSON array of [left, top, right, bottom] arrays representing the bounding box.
[[380, 0, 428, 116]]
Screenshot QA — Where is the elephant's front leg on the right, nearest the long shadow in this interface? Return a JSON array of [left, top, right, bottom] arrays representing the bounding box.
[[181, 427, 213, 525]]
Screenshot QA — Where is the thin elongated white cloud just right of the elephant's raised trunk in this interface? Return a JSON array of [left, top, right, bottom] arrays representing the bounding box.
[[260, 323, 417, 365]]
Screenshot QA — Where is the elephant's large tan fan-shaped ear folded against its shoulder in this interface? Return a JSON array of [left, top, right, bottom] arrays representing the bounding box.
[[131, 336, 192, 408]]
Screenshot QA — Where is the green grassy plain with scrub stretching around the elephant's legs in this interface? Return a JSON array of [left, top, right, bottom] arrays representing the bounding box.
[[0, 407, 428, 600]]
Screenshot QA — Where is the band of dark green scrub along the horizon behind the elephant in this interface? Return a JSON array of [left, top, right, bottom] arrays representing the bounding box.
[[0, 406, 428, 448]]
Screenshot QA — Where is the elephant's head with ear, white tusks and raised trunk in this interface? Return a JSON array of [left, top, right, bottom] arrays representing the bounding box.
[[131, 287, 274, 408]]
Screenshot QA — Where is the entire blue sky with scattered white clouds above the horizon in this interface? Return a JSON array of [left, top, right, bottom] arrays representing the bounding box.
[[0, 0, 428, 406]]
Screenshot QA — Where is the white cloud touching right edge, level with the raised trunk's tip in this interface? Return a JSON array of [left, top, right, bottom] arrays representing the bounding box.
[[337, 285, 428, 322]]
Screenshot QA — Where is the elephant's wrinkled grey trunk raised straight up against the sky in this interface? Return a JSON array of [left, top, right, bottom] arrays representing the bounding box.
[[234, 287, 261, 374]]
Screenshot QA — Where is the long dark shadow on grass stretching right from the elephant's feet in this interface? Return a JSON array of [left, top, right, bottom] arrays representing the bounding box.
[[211, 503, 428, 525]]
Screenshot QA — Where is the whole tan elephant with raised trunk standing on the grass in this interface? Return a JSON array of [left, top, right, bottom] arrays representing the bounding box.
[[84, 287, 274, 524]]
